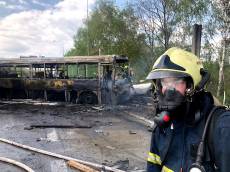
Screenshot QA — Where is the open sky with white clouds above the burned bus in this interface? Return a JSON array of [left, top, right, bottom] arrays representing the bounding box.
[[0, 0, 127, 58]]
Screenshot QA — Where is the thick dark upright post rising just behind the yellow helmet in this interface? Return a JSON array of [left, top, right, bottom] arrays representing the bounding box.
[[192, 24, 202, 57]]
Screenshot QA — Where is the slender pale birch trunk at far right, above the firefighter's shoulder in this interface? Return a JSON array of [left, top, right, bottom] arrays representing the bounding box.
[[216, 39, 226, 97]]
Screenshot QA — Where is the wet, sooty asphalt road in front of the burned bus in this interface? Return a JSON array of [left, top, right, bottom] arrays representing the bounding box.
[[0, 104, 151, 172]]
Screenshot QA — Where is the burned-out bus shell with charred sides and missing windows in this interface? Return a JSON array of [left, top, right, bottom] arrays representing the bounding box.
[[0, 55, 132, 104]]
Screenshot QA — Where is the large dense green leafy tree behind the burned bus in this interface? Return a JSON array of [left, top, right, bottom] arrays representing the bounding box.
[[66, 0, 145, 63]]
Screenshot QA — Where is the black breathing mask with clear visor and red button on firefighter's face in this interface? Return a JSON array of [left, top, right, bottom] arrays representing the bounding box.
[[154, 78, 186, 127]]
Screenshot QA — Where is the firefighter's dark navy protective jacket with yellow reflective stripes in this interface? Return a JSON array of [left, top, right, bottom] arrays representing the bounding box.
[[147, 93, 230, 172]]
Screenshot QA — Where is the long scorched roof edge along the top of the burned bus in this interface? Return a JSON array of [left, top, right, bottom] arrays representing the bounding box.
[[0, 55, 128, 64]]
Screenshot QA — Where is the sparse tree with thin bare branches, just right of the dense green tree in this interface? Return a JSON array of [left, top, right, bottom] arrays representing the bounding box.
[[135, 0, 175, 54]]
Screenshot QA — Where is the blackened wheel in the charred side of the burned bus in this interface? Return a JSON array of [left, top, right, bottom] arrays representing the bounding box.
[[78, 91, 98, 104]]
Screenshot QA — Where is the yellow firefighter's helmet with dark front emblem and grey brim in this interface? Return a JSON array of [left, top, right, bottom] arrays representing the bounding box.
[[146, 47, 203, 89]]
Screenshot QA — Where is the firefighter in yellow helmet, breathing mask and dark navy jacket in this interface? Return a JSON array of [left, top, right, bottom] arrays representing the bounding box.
[[147, 47, 230, 172]]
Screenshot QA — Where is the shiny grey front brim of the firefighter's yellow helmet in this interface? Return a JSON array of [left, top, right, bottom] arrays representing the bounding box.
[[146, 71, 189, 80]]
